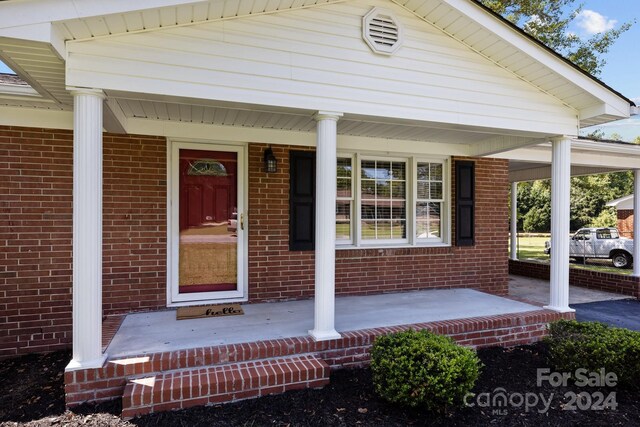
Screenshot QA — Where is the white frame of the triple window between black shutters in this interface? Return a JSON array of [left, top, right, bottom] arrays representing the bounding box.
[[336, 151, 452, 249]]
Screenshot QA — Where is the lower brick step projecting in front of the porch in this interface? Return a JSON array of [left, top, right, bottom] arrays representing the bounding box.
[[122, 355, 329, 419]]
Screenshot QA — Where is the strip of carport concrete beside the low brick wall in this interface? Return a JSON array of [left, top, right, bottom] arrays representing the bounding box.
[[509, 275, 630, 305]]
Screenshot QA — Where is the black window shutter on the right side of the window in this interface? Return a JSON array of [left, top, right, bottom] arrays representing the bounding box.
[[456, 162, 475, 246]]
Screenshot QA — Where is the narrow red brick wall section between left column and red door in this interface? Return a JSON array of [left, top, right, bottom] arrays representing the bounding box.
[[102, 135, 167, 314]]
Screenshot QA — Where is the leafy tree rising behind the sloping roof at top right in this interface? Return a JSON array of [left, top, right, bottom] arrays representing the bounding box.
[[480, 0, 635, 76]]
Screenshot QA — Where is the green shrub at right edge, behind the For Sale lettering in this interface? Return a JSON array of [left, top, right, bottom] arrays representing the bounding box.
[[545, 320, 640, 386]]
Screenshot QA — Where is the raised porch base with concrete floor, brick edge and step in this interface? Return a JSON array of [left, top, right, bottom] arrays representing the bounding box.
[[65, 289, 573, 418]]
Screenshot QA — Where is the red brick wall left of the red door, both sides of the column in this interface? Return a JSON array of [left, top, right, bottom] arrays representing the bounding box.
[[0, 127, 166, 357]]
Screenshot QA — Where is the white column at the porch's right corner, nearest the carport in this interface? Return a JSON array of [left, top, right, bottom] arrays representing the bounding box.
[[545, 138, 573, 312]]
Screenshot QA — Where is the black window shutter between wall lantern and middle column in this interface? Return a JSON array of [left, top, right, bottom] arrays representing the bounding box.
[[289, 151, 316, 251]]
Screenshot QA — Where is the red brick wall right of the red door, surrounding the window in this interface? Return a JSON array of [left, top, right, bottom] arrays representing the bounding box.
[[249, 144, 509, 302]]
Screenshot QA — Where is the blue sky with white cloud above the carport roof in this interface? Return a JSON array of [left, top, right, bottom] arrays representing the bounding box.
[[0, 0, 640, 141]]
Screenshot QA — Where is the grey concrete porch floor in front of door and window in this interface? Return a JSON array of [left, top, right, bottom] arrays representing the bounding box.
[[107, 289, 540, 358]]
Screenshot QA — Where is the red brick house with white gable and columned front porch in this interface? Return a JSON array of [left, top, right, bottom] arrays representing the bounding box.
[[0, 0, 635, 415]]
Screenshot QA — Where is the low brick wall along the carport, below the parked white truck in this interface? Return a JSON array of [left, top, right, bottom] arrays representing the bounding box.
[[509, 259, 640, 298]]
